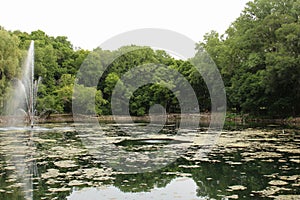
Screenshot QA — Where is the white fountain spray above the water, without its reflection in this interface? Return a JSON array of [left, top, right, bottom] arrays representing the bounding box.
[[6, 41, 40, 127]]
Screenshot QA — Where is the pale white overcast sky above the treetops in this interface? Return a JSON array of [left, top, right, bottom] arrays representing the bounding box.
[[0, 0, 250, 50]]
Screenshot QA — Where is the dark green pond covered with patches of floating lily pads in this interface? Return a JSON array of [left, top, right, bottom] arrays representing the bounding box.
[[0, 123, 300, 200]]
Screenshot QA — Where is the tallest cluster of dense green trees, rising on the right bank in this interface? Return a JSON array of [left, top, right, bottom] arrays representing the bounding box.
[[199, 0, 300, 116]]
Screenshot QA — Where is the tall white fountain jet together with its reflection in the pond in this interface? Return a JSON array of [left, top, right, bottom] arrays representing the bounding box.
[[1, 41, 40, 200]]
